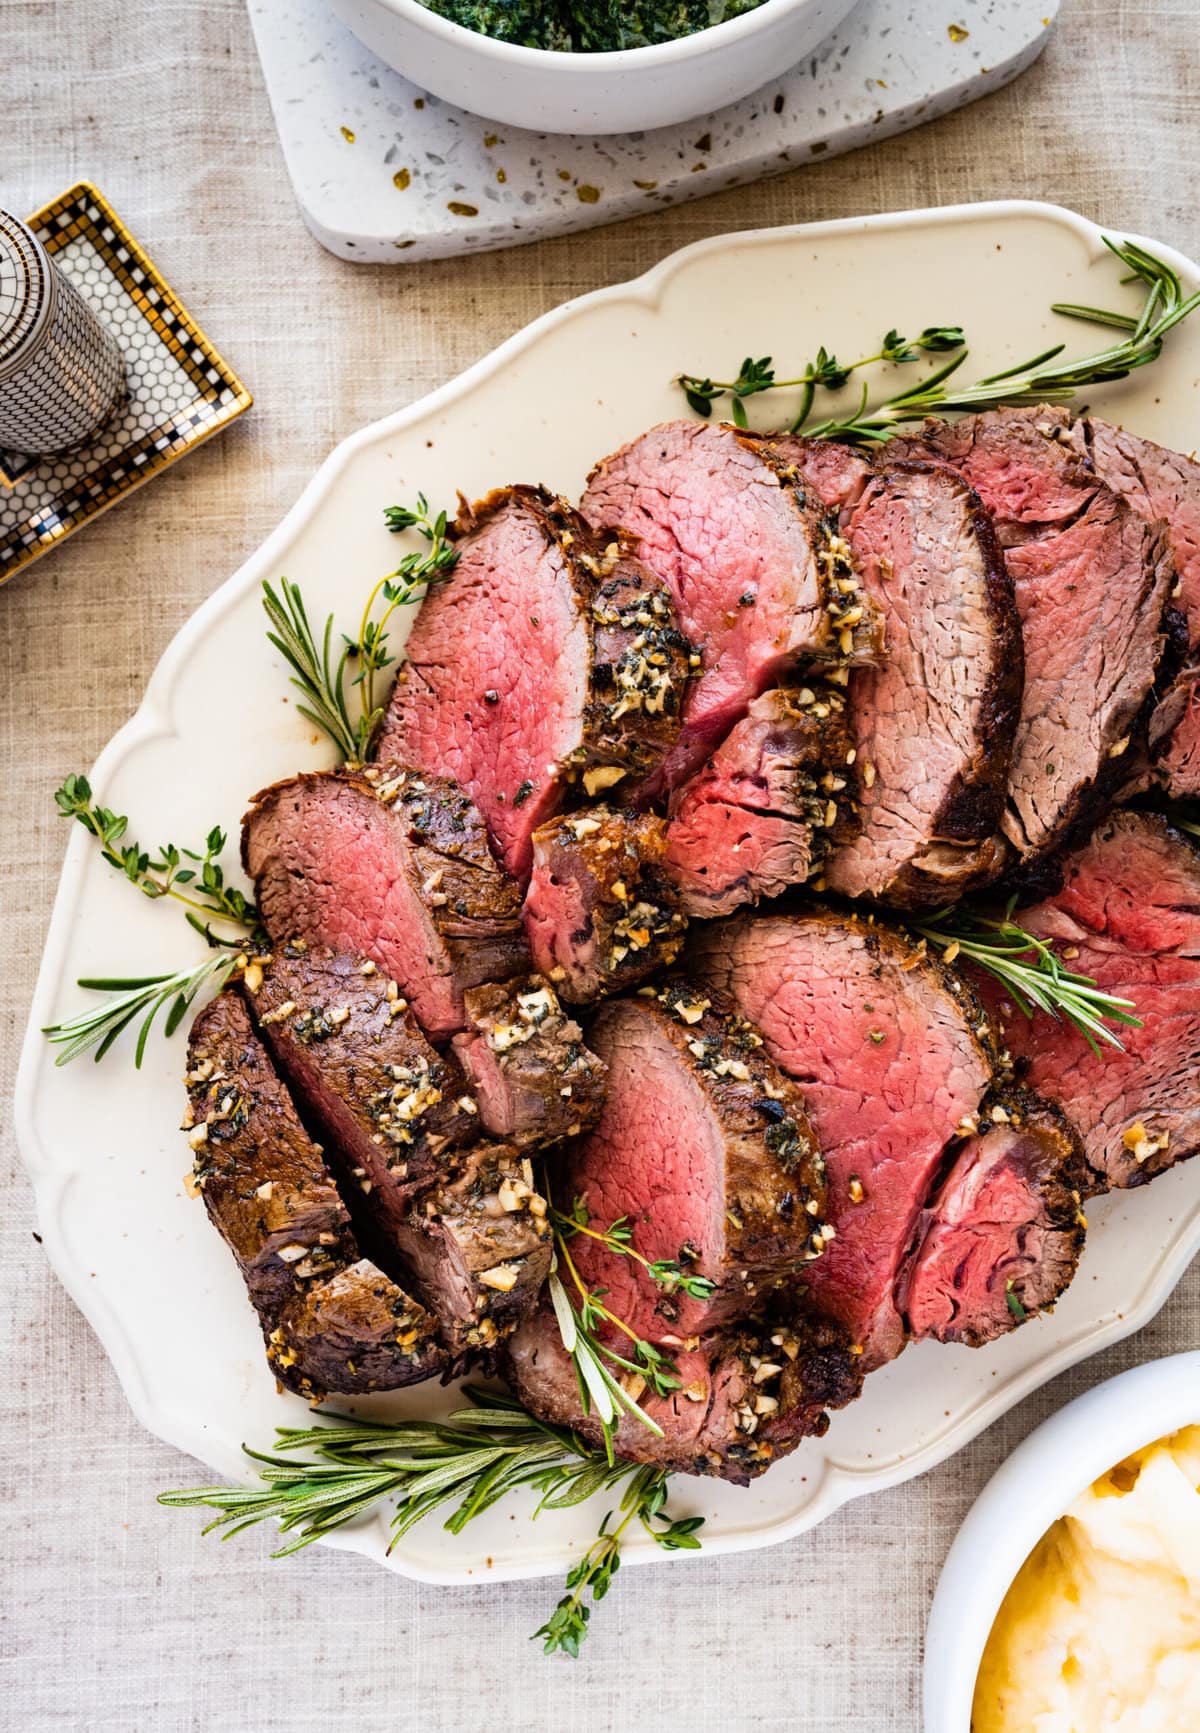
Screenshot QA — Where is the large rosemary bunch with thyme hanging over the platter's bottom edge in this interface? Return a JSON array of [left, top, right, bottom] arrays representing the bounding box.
[[158, 1386, 704, 1658]]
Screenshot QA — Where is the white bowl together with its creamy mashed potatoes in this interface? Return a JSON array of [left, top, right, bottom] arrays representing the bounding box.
[[924, 1353, 1200, 1733]]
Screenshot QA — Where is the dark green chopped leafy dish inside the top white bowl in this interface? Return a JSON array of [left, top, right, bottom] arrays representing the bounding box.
[[423, 0, 763, 54]]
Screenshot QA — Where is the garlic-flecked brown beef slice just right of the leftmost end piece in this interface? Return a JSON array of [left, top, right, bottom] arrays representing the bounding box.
[[243, 939, 480, 1234]]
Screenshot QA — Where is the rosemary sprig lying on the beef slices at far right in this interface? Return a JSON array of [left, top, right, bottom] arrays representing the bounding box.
[[912, 898, 1141, 1054]]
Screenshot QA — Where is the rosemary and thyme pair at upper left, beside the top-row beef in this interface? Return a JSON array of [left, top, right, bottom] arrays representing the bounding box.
[[262, 494, 458, 764]]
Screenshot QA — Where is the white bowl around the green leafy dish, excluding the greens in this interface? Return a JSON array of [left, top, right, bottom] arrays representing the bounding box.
[[331, 0, 855, 133]]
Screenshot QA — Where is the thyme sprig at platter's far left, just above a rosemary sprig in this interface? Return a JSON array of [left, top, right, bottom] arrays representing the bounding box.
[[54, 776, 258, 944]]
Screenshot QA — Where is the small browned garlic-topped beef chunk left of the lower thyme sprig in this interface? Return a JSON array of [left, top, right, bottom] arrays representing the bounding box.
[[386, 1144, 551, 1355]]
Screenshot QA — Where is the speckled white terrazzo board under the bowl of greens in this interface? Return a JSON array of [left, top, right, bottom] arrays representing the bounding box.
[[250, 0, 1060, 263]]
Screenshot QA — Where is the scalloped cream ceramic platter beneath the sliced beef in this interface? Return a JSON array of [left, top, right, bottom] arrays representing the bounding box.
[[17, 203, 1200, 1582]]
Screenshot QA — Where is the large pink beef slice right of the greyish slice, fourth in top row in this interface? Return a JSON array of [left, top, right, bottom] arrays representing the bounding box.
[[895, 407, 1179, 861]]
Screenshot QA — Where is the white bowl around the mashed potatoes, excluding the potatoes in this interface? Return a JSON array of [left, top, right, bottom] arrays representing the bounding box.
[[924, 1352, 1200, 1733]]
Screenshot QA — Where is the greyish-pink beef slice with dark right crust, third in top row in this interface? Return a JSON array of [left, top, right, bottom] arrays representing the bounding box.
[[805, 459, 1023, 908]]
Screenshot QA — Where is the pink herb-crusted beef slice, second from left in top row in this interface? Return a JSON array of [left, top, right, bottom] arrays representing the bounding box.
[[583, 421, 879, 792]]
